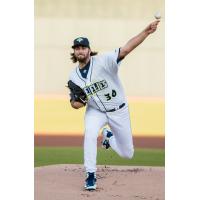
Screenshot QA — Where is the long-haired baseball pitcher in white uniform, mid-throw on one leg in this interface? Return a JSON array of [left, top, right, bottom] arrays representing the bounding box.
[[67, 20, 159, 190]]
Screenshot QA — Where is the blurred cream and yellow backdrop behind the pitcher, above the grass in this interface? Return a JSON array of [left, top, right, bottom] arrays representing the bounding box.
[[34, 0, 165, 147]]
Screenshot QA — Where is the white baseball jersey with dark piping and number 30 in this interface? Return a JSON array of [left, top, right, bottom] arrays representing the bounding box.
[[69, 49, 127, 112]]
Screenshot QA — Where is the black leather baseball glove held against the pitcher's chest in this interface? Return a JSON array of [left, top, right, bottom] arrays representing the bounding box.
[[68, 80, 87, 105]]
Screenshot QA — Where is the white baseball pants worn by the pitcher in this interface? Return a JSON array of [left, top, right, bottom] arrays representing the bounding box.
[[84, 105, 134, 172]]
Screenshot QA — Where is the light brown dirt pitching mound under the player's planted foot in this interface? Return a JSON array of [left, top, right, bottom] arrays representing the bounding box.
[[35, 164, 165, 200]]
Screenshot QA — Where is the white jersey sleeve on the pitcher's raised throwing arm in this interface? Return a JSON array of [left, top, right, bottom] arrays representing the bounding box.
[[104, 48, 121, 73]]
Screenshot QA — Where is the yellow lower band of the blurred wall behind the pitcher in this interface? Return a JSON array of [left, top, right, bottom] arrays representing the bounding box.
[[35, 96, 164, 136]]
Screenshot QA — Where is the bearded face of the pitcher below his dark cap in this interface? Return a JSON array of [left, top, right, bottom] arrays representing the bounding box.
[[74, 46, 91, 62]]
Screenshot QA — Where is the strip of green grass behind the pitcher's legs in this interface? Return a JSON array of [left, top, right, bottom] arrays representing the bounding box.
[[34, 147, 165, 167]]
